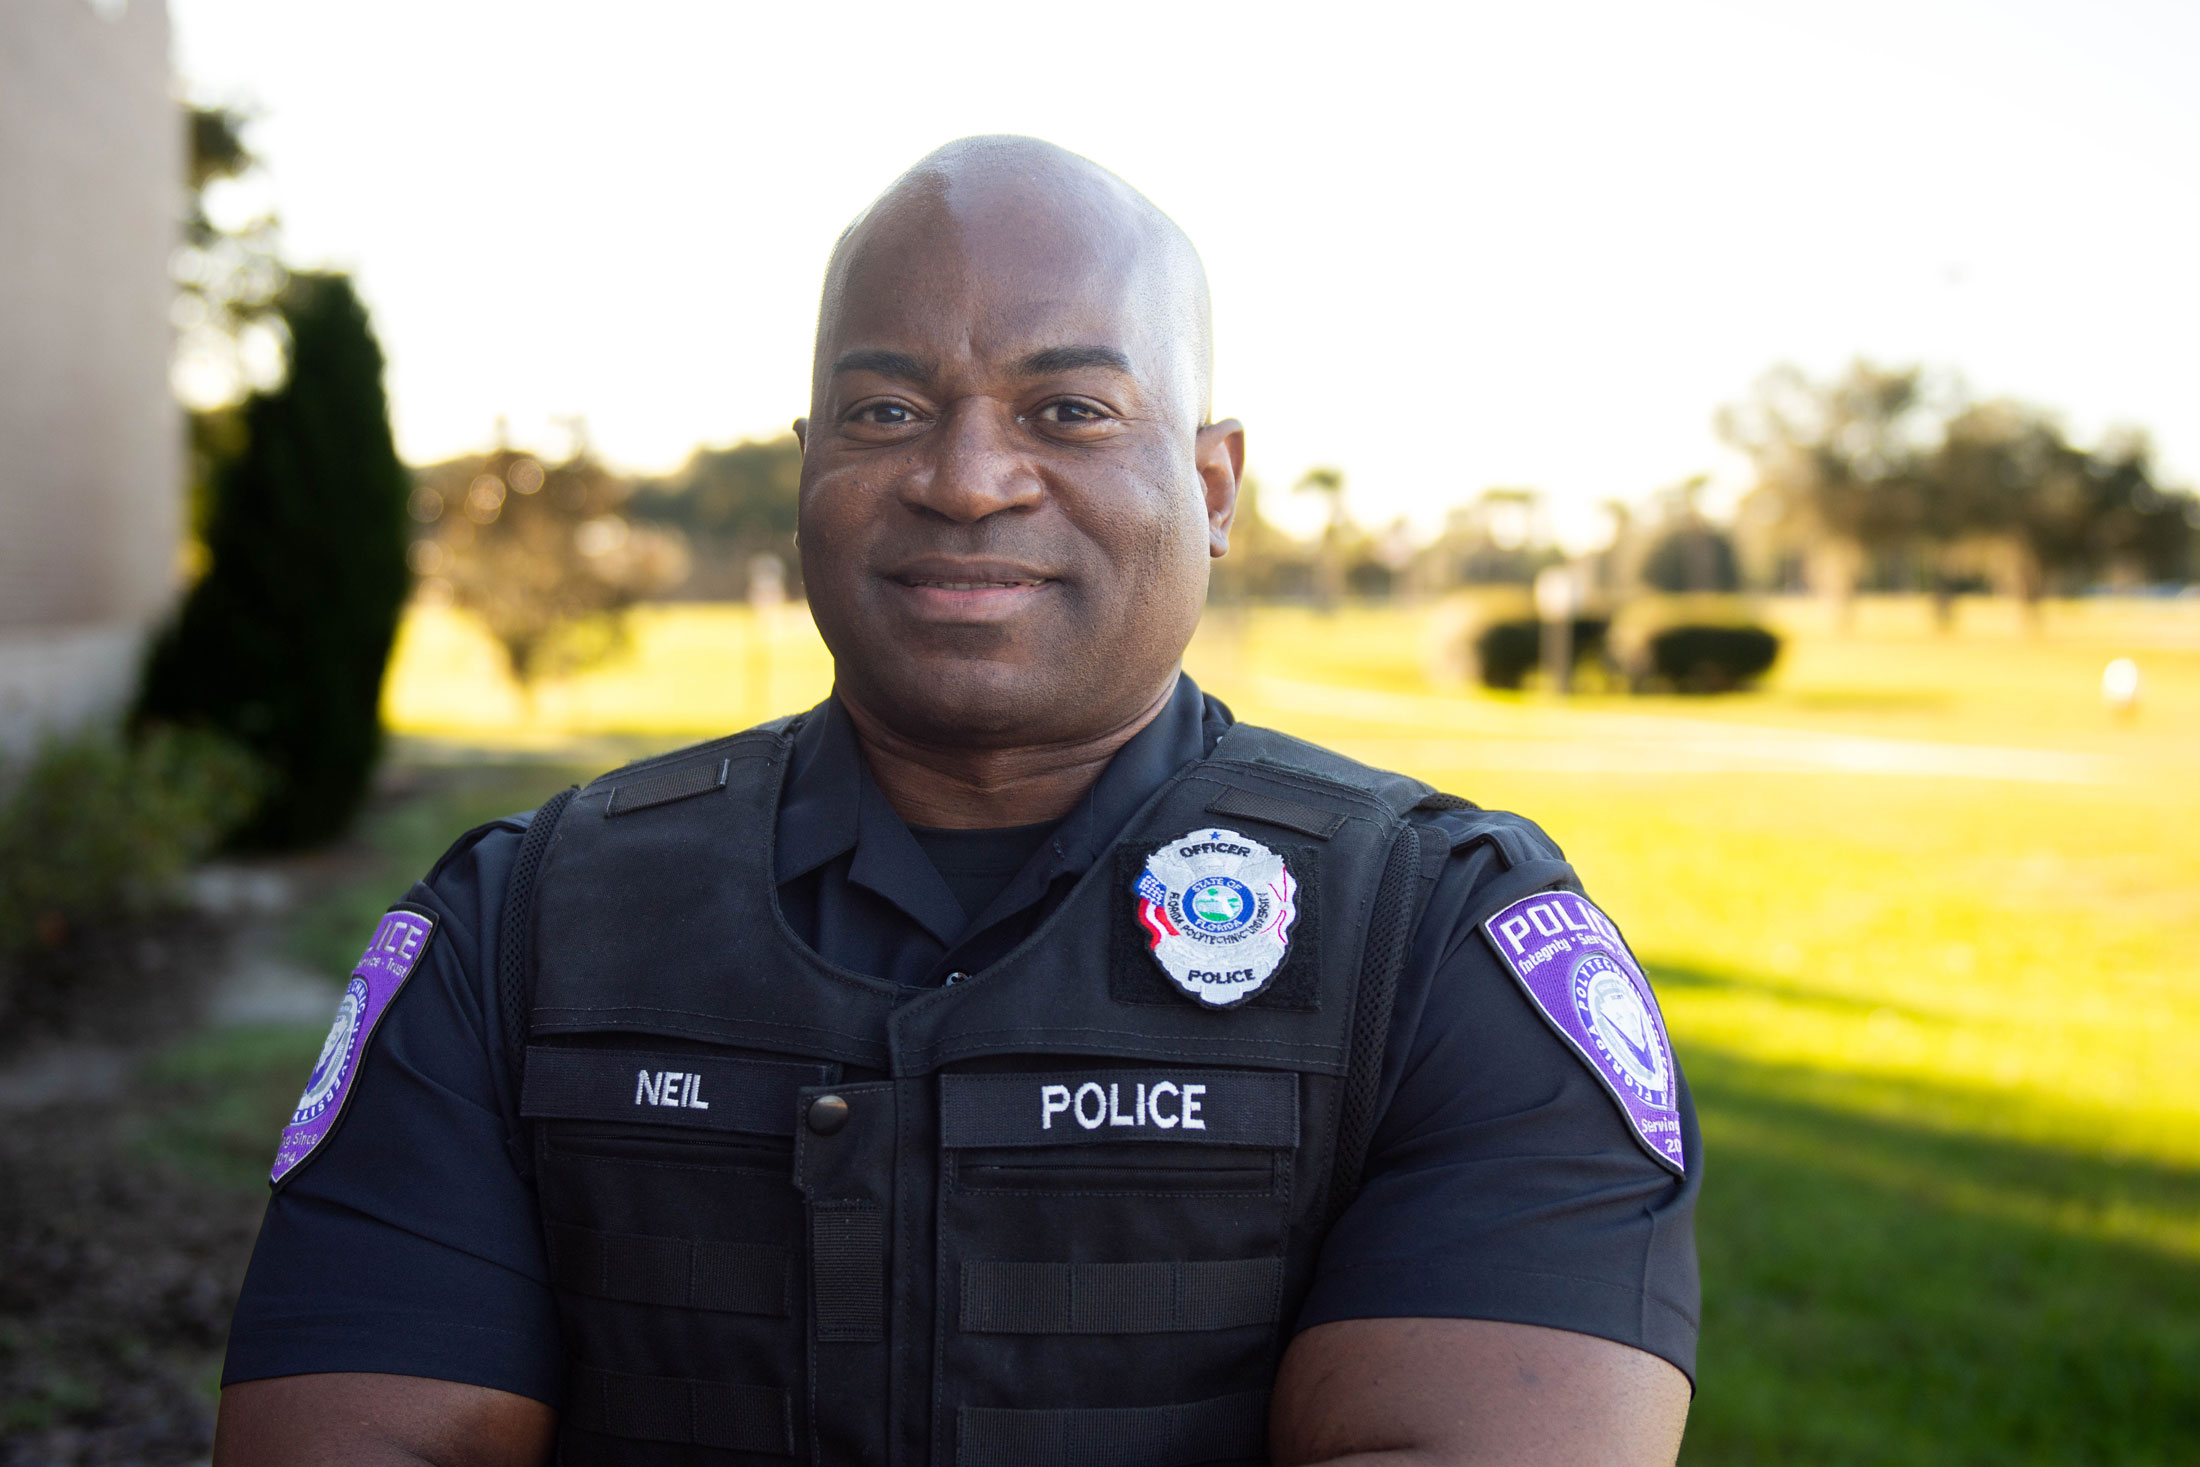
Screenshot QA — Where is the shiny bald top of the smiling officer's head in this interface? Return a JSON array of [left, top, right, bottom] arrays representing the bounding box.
[[810, 136, 1214, 429]]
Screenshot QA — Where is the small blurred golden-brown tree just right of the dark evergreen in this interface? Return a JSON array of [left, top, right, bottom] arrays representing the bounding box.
[[411, 449, 686, 688]]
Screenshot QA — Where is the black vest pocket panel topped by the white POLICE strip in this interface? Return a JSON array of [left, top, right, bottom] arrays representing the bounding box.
[[933, 1067, 1300, 1467]]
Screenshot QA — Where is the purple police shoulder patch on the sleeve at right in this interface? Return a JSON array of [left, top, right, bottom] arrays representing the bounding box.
[[1483, 891, 1687, 1174]]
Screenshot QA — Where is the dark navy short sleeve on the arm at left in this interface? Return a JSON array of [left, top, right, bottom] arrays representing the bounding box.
[[222, 820, 563, 1405]]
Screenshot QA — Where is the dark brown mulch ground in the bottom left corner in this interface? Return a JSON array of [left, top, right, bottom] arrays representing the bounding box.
[[0, 917, 264, 1467]]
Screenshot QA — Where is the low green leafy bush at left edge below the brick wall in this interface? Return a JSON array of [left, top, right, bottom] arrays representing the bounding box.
[[0, 728, 260, 961]]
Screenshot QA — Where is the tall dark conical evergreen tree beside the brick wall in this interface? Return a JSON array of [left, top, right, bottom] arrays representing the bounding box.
[[132, 273, 409, 847]]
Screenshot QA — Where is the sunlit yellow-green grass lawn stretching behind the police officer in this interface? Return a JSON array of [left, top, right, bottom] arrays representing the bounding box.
[[218, 603, 2200, 1465]]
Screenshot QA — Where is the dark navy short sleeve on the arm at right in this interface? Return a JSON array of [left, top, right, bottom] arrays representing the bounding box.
[[1298, 814, 1703, 1379]]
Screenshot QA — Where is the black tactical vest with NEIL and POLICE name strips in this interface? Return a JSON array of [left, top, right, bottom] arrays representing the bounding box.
[[499, 724, 1461, 1467]]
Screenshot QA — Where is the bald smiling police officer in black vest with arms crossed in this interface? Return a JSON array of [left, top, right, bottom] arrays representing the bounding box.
[[216, 139, 1701, 1467]]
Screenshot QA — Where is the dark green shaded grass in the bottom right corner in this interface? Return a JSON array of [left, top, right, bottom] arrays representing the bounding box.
[[1681, 1049, 2200, 1467]]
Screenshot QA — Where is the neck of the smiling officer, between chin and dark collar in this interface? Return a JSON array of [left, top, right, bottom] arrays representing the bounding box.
[[840, 677, 1177, 829]]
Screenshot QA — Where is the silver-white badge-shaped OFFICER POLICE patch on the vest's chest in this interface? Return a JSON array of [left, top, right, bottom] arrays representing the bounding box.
[[1137, 829, 1298, 1010]]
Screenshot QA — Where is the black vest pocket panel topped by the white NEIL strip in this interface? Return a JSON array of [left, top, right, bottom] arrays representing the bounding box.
[[521, 1047, 836, 1467]]
